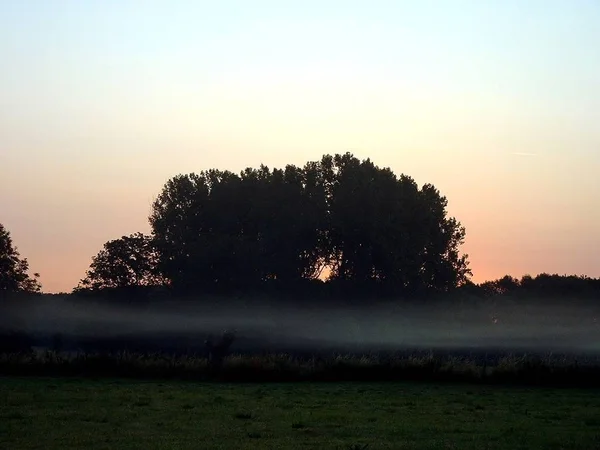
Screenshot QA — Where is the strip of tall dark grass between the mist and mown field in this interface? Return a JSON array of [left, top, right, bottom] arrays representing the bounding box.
[[0, 350, 600, 387]]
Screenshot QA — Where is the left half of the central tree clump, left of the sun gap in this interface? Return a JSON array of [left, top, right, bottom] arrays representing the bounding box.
[[149, 165, 326, 290]]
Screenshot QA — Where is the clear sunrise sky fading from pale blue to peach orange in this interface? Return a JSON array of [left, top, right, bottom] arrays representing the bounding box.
[[0, 0, 600, 292]]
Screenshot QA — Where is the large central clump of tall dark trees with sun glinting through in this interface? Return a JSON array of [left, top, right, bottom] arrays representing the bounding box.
[[149, 153, 470, 298]]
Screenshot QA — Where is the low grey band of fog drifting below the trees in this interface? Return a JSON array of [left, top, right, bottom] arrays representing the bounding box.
[[0, 296, 600, 353]]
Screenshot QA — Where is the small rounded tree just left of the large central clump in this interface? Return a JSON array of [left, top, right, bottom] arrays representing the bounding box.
[[76, 233, 163, 290]]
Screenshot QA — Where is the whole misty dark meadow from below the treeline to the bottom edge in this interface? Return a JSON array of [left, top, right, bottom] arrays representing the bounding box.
[[0, 294, 600, 450]]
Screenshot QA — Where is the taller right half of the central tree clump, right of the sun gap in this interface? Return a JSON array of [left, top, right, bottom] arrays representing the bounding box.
[[323, 153, 470, 292]]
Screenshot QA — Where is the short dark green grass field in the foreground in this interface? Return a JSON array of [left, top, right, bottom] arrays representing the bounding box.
[[0, 378, 600, 450]]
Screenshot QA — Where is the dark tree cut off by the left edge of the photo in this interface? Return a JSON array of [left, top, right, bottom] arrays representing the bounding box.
[[0, 224, 42, 293]]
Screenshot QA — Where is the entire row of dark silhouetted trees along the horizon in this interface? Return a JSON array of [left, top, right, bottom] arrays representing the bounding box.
[[0, 153, 598, 298]]
